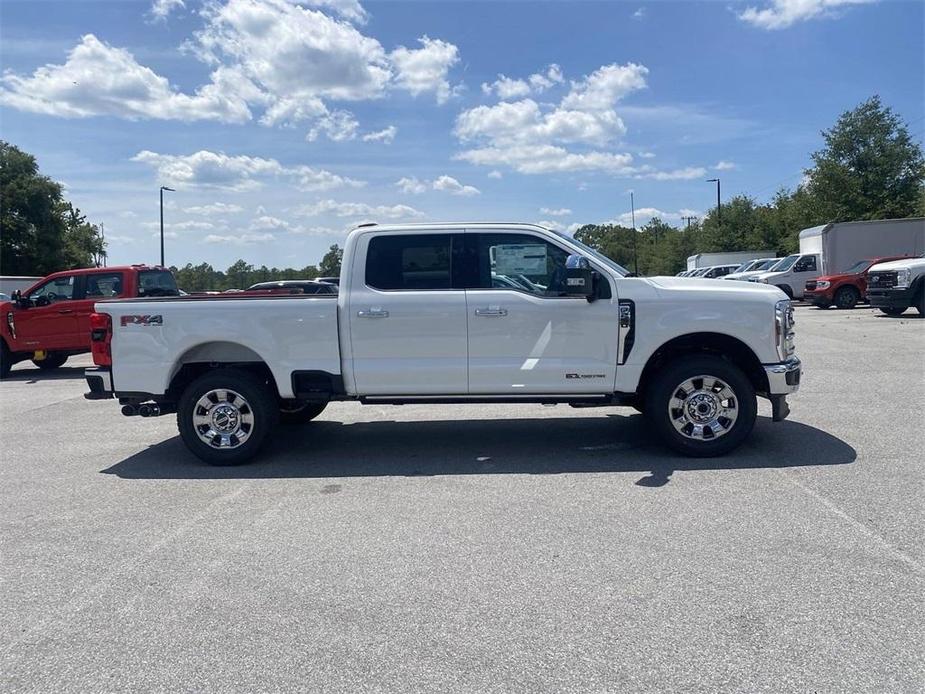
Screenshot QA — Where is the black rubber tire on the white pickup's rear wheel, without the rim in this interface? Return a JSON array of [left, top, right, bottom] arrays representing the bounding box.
[[177, 369, 279, 465]]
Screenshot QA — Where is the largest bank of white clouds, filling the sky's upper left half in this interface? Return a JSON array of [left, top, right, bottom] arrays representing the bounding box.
[[0, 0, 459, 141]]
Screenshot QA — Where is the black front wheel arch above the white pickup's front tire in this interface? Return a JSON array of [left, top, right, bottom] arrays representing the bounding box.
[[637, 332, 770, 394]]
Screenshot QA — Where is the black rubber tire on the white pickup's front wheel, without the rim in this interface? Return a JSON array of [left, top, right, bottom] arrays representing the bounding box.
[[646, 355, 758, 458]]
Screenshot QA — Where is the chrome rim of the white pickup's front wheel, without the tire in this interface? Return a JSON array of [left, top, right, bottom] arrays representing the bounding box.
[[668, 374, 739, 441]]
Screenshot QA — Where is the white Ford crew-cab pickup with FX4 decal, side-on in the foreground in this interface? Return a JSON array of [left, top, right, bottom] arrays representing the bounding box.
[[86, 223, 801, 465]]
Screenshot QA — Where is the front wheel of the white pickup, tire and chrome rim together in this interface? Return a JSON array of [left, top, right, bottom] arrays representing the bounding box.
[[646, 355, 758, 458]]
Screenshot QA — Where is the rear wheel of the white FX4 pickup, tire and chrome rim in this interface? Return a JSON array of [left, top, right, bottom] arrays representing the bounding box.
[[177, 369, 279, 465]]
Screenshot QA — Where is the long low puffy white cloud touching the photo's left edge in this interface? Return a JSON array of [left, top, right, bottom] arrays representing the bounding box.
[[0, 34, 251, 123]]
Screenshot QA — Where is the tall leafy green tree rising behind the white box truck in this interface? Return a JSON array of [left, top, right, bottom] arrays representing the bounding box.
[[806, 96, 925, 222]]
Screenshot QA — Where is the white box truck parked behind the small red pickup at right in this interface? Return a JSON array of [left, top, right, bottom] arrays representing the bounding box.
[[749, 217, 925, 299]]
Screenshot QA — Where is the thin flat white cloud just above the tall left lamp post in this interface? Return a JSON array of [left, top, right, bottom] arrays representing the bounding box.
[[132, 150, 364, 191]]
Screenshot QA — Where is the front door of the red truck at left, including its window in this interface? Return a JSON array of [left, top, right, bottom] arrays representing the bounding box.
[[13, 275, 80, 352]]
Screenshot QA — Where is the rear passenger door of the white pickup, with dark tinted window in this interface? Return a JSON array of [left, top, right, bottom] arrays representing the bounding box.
[[347, 234, 468, 395]]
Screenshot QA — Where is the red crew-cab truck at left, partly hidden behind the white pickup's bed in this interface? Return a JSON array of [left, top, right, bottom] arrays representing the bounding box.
[[0, 265, 179, 377]]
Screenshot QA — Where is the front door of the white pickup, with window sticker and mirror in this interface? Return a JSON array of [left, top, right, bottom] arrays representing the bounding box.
[[466, 231, 619, 395]]
